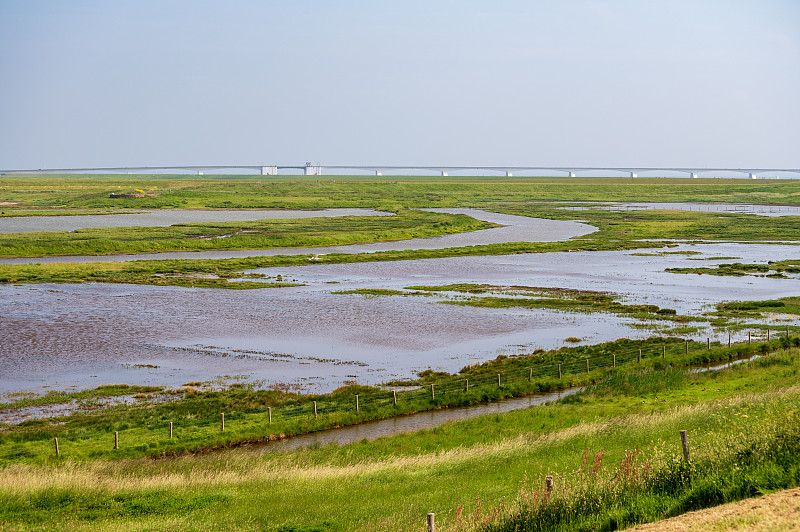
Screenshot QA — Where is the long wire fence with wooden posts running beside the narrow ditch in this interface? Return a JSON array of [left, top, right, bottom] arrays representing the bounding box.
[[0, 327, 800, 463]]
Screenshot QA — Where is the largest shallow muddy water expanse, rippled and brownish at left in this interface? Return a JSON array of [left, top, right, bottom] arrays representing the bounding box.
[[0, 244, 800, 392]]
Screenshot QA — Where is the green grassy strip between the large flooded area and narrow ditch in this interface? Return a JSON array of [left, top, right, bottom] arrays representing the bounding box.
[[0, 338, 797, 463]]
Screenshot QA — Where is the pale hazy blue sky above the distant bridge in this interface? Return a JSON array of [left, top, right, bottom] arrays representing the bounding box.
[[0, 0, 800, 169]]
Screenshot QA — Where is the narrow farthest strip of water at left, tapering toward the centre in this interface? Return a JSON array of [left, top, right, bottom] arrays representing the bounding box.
[[0, 209, 392, 233]]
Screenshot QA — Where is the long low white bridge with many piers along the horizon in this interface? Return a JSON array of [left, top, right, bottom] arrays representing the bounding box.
[[0, 163, 800, 179]]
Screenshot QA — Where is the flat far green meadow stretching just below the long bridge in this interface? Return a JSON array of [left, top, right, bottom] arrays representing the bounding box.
[[0, 175, 800, 210]]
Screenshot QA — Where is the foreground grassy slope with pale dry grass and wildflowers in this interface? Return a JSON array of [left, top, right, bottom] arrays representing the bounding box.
[[0, 342, 800, 531]]
